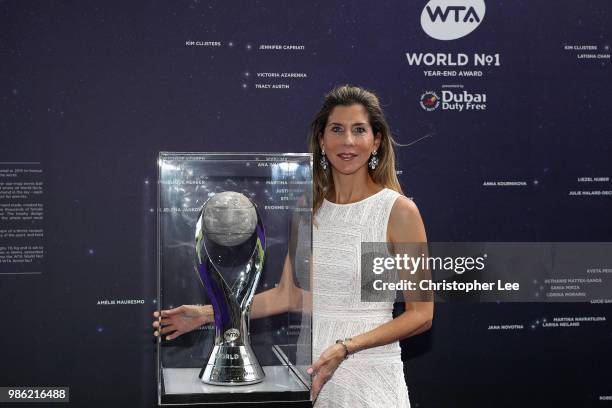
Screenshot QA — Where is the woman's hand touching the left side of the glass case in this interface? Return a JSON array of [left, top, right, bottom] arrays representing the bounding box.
[[153, 305, 214, 340]]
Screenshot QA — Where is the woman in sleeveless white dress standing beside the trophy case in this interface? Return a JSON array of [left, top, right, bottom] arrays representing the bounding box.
[[153, 86, 433, 408]]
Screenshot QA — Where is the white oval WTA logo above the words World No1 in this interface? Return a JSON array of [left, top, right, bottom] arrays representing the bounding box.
[[421, 0, 485, 41]]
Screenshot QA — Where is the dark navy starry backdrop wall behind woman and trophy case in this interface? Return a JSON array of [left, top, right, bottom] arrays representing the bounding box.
[[0, 0, 612, 407]]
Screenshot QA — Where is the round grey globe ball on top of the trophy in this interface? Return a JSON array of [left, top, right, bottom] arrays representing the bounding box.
[[203, 191, 257, 247]]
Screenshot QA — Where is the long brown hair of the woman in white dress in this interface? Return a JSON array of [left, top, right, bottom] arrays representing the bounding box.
[[308, 85, 403, 214]]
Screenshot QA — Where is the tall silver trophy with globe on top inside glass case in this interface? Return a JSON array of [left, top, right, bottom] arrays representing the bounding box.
[[195, 191, 265, 385]]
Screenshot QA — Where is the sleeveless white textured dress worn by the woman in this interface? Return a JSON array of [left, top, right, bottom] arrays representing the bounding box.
[[312, 188, 410, 408]]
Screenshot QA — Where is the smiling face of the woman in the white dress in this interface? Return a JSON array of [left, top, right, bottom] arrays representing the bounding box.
[[319, 104, 381, 174]]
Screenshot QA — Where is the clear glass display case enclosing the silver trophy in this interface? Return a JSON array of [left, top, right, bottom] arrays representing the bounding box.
[[157, 152, 312, 405]]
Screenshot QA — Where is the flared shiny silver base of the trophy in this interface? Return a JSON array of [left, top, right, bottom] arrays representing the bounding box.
[[200, 345, 265, 386]]
